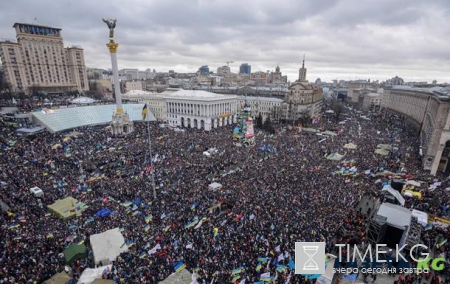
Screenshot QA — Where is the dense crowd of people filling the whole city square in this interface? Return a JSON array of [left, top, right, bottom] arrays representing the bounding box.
[[0, 100, 450, 283]]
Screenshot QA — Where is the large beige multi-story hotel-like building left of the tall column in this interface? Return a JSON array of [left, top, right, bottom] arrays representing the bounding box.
[[0, 23, 89, 94]]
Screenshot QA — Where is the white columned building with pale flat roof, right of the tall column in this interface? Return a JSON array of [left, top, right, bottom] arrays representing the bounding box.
[[162, 90, 238, 131]]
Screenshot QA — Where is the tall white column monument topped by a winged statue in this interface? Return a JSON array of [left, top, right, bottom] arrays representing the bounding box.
[[103, 19, 134, 136]]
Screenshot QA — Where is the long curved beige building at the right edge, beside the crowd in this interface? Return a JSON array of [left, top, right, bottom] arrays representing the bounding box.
[[382, 86, 450, 174]]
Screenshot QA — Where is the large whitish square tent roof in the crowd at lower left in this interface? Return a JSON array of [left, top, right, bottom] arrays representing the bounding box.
[[90, 228, 128, 264]]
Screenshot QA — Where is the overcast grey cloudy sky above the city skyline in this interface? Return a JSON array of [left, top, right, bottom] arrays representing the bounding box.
[[0, 0, 450, 83]]
